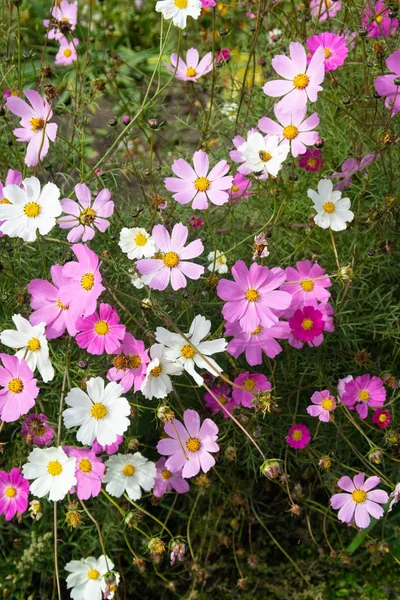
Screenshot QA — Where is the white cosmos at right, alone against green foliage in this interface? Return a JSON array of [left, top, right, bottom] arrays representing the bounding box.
[[307, 179, 354, 231]]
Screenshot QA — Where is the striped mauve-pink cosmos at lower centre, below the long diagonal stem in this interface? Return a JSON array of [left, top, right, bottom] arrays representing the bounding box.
[[157, 410, 219, 479]]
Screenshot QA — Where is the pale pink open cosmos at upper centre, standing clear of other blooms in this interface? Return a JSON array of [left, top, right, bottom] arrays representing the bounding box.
[[164, 150, 233, 209]]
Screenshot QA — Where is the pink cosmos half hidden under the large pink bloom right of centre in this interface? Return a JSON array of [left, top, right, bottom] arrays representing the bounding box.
[[225, 321, 290, 367]]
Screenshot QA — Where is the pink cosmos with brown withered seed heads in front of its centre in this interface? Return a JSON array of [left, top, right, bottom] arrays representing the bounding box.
[[107, 333, 150, 392]]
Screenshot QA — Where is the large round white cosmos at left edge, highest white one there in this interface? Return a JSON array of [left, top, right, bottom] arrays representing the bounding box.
[[0, 177, 62, 242]]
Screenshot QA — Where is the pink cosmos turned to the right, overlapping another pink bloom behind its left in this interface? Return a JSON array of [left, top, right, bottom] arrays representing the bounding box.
[[60, 244, 105, 317]]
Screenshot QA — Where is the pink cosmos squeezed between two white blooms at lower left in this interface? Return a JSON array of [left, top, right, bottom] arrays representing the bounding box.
[[63, 446, 105, 500]]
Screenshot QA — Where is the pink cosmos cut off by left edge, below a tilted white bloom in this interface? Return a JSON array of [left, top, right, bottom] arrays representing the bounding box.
[[0, 354, 39, 423]]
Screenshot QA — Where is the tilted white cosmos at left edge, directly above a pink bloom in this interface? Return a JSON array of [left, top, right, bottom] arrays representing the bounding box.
[[0, 315, 54, 383]]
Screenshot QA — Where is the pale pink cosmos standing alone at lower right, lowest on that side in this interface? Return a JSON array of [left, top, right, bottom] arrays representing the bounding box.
[[331, 473, 389, 529]]
